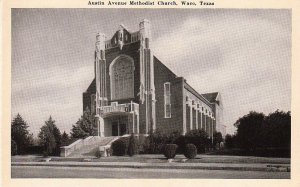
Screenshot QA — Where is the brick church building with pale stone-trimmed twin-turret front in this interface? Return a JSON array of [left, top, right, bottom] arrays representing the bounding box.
[[83, 20, 224, 137]]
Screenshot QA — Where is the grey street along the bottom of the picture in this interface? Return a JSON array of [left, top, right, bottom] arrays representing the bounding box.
[[11, 166, 290, 179]]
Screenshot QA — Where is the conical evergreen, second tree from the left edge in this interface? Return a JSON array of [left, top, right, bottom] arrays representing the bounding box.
[[39, 116, 61, 156]]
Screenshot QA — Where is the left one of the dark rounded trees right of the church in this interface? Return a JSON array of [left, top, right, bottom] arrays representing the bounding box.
[[234, 111, 265, 151]]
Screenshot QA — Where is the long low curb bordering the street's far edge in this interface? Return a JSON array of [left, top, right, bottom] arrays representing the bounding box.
[[11, 162, 290, 172]]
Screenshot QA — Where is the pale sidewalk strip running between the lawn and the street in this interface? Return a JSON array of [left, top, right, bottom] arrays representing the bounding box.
[[11, 161, 290, 172]]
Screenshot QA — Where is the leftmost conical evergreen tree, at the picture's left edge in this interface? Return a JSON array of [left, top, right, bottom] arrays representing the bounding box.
[[11, 114, 32, 154]]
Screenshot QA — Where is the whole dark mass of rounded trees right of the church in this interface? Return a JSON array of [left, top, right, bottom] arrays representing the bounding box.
[[230, 110, 291, 153]]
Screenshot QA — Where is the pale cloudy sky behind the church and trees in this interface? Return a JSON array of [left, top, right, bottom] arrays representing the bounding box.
[[11, 9, 292, 136]]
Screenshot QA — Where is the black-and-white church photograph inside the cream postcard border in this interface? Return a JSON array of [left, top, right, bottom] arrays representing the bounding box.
[[7, 6, 294, 180]]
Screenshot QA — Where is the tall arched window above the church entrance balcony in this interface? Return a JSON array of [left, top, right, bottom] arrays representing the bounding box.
[[109, 55, 134, 100]]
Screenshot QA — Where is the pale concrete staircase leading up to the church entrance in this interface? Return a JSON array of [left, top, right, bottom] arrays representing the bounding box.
[[68, 136, 119, 158]]
